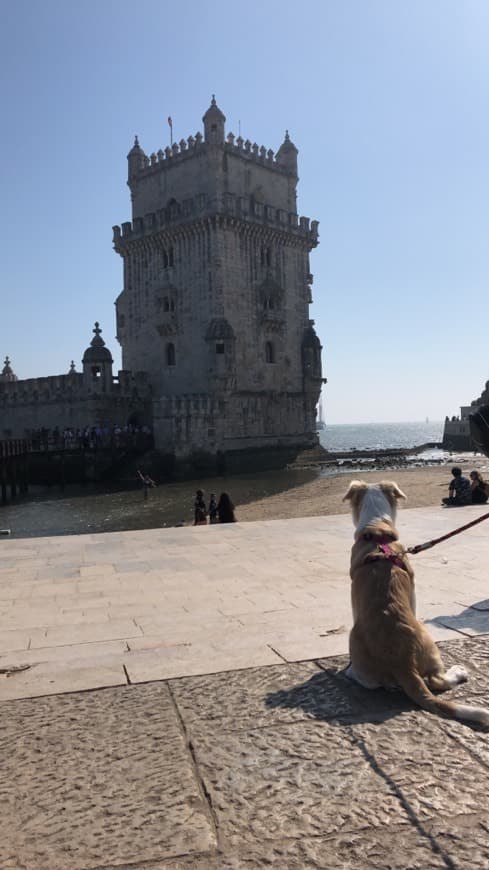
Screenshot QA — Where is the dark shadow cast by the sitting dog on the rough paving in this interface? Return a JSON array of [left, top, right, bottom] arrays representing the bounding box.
[[265, 656, 418, 724]]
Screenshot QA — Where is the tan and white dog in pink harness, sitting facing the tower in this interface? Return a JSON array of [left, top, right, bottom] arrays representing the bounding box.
[[343, 480, 489, 726]]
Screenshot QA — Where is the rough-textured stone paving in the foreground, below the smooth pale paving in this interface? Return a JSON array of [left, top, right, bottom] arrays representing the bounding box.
[[0, 636, 489, 870]]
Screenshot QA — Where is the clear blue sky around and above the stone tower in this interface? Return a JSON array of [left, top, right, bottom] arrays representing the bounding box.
[[0, 0, 489, 423]]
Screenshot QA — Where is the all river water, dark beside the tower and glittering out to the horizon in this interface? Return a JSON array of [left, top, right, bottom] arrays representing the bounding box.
[[0, 423, 450, 544]]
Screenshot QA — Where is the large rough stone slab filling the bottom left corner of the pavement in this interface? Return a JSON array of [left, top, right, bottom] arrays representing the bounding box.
[[0, 685, 216, 870]]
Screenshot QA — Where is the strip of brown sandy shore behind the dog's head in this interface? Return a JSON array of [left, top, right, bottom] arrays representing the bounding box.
[[236, 458, 489, 521]]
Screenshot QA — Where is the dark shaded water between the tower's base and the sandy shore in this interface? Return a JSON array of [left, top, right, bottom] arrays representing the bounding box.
[[0, 470, 318, 545]]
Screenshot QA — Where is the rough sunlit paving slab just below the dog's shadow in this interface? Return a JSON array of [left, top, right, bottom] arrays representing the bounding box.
[[189, 722, 408, 846]]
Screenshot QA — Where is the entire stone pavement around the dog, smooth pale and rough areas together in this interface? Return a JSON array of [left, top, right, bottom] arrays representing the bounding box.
[[0, 508, 489, 870]]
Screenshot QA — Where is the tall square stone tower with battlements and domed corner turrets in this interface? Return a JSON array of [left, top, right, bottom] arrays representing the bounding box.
[[114, 97, 322, 466]]
